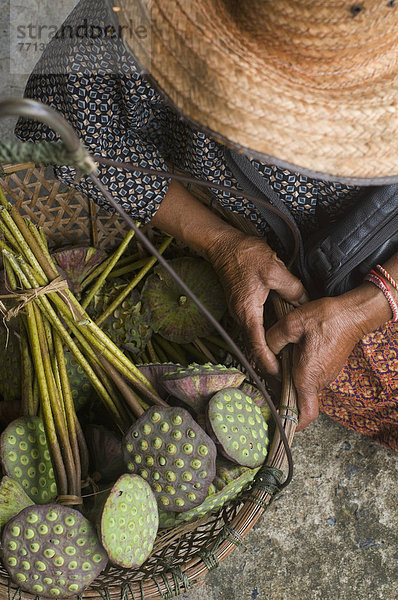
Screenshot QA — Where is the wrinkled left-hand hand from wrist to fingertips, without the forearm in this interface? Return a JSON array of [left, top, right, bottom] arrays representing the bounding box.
[[208, 230, 307, 375]]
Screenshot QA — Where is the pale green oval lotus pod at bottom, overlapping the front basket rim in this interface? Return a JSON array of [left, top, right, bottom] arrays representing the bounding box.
[[100, 474, 159, 569]]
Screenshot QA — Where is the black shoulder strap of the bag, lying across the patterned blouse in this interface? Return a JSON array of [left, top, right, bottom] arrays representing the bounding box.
[[224, 148, 304, 269]]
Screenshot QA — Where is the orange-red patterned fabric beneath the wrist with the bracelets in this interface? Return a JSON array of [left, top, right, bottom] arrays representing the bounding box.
[[320, 323, 398, 451]]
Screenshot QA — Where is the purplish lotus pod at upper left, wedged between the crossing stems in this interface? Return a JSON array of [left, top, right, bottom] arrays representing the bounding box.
[[52, 246, 107, 295]]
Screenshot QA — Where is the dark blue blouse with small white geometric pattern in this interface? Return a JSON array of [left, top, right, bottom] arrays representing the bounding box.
[[15, 0, 358, 244]]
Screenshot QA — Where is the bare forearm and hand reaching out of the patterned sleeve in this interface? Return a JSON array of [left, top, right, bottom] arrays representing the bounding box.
[[152, 181, 306, 374]]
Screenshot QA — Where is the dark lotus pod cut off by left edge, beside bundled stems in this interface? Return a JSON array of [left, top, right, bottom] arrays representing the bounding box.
[[0, 324, 21, 402]]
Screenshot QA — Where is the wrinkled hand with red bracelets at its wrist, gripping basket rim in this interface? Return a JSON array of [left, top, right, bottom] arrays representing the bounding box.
[[266, 294, 365, 431]]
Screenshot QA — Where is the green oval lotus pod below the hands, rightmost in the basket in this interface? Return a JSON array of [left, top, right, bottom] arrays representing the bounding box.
[[207, 388, 269, 468]]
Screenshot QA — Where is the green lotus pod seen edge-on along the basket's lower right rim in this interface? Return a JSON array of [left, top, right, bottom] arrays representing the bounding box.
[[159, 467, 260, 529]]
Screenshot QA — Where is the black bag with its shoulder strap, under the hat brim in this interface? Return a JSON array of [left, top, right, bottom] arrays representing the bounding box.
[[225, 149, 398, 298]]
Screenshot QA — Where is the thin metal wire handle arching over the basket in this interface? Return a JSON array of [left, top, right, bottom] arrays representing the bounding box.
[[0, 98, 293, 489]]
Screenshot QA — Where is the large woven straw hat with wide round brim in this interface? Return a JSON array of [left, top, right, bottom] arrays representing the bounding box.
[[114, 0, 398, 183]]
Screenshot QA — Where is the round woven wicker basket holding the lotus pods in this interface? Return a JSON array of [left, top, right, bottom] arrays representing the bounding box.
[[0, 163, 297, 600]]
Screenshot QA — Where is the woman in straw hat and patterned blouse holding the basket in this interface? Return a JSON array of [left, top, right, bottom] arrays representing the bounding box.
[[16, 0, 398, 440]]
